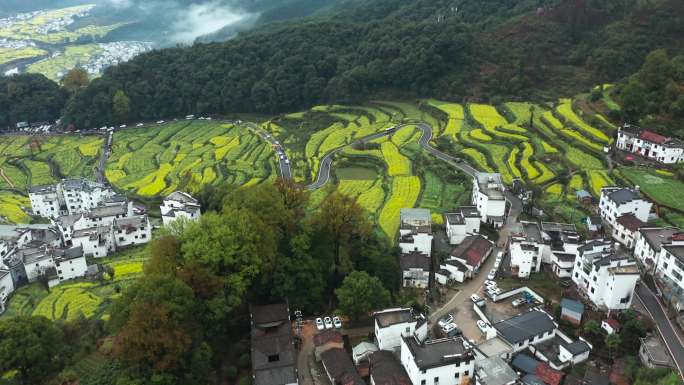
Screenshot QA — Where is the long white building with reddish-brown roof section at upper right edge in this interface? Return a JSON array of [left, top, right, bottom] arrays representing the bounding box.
[[615, 124, 684, 164]]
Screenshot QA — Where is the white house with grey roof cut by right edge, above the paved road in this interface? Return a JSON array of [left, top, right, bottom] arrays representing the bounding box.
[[634, 227, 684, 272]]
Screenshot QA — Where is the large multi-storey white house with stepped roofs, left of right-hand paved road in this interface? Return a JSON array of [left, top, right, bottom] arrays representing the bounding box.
[[572, 240, 639, 310]]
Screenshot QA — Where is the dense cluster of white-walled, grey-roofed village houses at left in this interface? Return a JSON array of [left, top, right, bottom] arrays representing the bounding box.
[[0, 179, 200, 312]]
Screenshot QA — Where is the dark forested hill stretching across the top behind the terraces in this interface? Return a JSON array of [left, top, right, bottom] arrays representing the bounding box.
[[8, 0, 684, 128]]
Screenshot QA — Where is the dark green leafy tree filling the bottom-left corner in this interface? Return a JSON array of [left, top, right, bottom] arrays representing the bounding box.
[[0, 316, 64, 385]]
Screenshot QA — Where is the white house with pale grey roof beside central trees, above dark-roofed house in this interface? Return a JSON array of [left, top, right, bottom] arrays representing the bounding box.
[[399, 209, 433, 256]]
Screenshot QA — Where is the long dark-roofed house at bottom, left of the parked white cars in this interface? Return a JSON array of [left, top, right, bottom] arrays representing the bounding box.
[[249, 303, 296, 385]]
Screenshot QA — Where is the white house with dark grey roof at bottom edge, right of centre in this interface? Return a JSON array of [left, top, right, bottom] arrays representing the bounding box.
[[401, 336, 475, 385]]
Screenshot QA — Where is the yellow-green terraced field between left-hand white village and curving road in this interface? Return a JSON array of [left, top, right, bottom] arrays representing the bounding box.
[[105, 121, 276, 197]]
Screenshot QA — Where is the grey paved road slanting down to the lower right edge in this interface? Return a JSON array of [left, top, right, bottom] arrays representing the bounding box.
[[635, 284, 684, 377]]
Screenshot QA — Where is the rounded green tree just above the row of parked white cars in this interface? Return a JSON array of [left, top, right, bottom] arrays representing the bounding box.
[[335, 271, 390, 320]]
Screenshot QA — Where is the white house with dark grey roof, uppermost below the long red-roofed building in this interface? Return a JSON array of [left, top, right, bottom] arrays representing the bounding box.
[[599, 186, 653, 227]]
